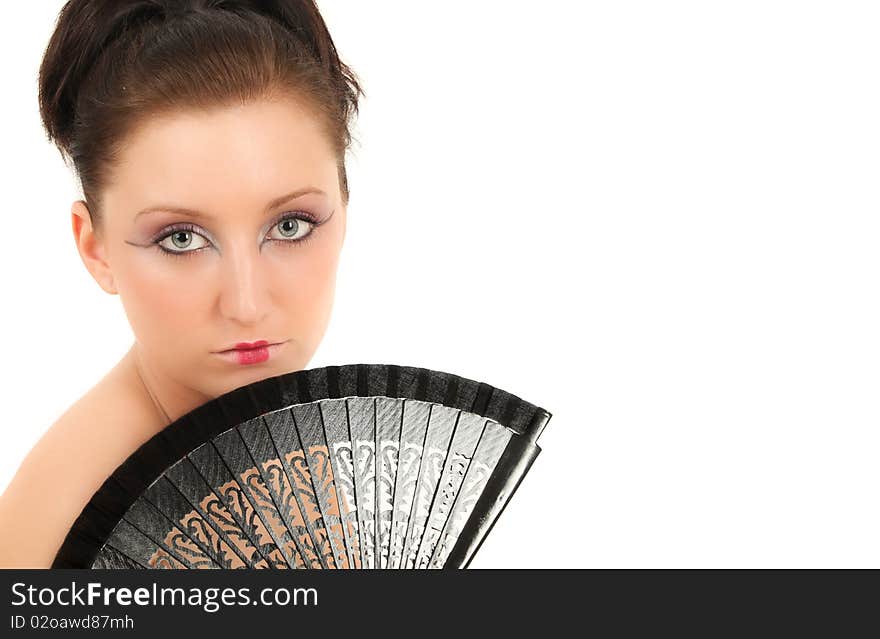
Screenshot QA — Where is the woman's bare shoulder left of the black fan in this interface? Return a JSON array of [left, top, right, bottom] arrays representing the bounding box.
[[0, 376, 156, 568]]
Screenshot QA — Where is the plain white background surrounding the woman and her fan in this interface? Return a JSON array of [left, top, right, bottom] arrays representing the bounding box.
[[0, 0, 880, 568]]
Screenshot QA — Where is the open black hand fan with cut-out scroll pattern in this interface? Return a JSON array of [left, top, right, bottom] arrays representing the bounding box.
[[52, 364, 551, 569]]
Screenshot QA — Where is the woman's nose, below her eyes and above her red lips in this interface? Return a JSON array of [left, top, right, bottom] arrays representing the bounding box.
[[220, 246, 269, 324]]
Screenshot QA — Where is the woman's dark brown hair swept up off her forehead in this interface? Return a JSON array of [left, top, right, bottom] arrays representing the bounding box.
[[38, 0, 365, 228]]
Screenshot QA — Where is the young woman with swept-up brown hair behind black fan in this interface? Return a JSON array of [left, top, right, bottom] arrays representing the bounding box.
[[0, 0, 364, 568]]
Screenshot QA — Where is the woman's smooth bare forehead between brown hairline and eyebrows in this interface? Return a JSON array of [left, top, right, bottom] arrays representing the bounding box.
[[107, 103, 338, 215]]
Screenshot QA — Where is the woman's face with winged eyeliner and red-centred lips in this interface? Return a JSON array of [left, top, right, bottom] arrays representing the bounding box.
[[75, 100, 346, 397]]
